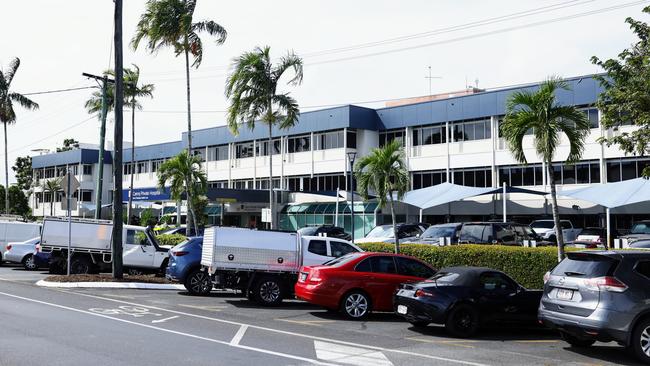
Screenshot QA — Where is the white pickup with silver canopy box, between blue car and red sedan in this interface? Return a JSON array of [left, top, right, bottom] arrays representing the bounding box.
[[200, 227, 362, 306]]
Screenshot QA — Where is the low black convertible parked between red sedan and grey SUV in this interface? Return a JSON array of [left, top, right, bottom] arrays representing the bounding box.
[[394, 267, 542, 337]]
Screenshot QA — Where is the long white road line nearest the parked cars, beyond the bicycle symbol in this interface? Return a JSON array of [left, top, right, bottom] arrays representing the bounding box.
[[67, 291, 487, 366]]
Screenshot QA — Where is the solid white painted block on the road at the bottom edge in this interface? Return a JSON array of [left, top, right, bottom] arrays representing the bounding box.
[[314, 341, 393, 366]]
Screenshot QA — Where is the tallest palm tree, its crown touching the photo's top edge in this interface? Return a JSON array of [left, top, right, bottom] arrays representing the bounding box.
[[131, 0, 227, 152]]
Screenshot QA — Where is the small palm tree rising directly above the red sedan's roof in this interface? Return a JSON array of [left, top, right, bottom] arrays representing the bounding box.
[[354, 140, 410, 253]]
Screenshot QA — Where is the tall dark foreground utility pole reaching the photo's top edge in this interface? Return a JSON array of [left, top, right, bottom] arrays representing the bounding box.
[[112, 0, 124, 279]]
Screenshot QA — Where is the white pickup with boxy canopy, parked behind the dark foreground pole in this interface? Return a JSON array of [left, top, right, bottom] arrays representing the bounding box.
[[41, 217, 169, 274]]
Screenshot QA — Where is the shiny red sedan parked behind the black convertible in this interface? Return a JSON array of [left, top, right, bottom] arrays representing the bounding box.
[[295, 252, 436, 319]]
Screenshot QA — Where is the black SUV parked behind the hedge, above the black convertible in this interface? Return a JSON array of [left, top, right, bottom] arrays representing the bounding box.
[[458, 222, 541, 245]]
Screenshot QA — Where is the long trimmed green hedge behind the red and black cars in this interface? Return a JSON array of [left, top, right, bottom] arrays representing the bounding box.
[[359, 243, 557, 289]]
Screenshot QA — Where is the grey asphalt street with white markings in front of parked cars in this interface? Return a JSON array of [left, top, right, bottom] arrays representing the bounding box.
[[0, 266, 636, 365]]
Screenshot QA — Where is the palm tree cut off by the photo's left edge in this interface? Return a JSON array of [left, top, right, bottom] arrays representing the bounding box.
[[0, 57, 38, 212]]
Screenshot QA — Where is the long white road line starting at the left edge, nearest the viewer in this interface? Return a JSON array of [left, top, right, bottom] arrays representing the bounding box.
[[0, 292, 336, 366]]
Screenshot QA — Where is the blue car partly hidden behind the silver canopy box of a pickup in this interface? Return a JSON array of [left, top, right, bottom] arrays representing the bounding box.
[[165, 236, 212, 295]]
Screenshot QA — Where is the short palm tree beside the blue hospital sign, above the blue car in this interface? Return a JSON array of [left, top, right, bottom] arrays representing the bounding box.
[[158, 150, 208, 236]]
